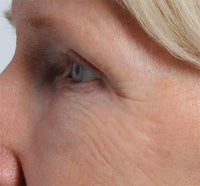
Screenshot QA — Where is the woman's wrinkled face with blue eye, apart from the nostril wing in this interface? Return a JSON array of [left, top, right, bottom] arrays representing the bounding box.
[[0, 0, 200, 186]]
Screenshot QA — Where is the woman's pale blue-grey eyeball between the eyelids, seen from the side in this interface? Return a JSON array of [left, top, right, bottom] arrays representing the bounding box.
[[71, 63, 100, 83]]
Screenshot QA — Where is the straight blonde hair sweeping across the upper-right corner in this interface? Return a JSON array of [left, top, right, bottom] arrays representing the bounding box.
[[118, 0, 200, 68]]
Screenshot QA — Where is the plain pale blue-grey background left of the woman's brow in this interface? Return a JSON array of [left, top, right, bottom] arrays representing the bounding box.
[[0, 0, 16, 73]]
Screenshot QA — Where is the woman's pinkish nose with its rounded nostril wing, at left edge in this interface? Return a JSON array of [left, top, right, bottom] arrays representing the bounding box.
[[0, 60, 28, 186]]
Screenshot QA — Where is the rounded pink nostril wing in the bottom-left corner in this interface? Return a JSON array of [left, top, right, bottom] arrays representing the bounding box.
[[0, 147, 26, 186]]
